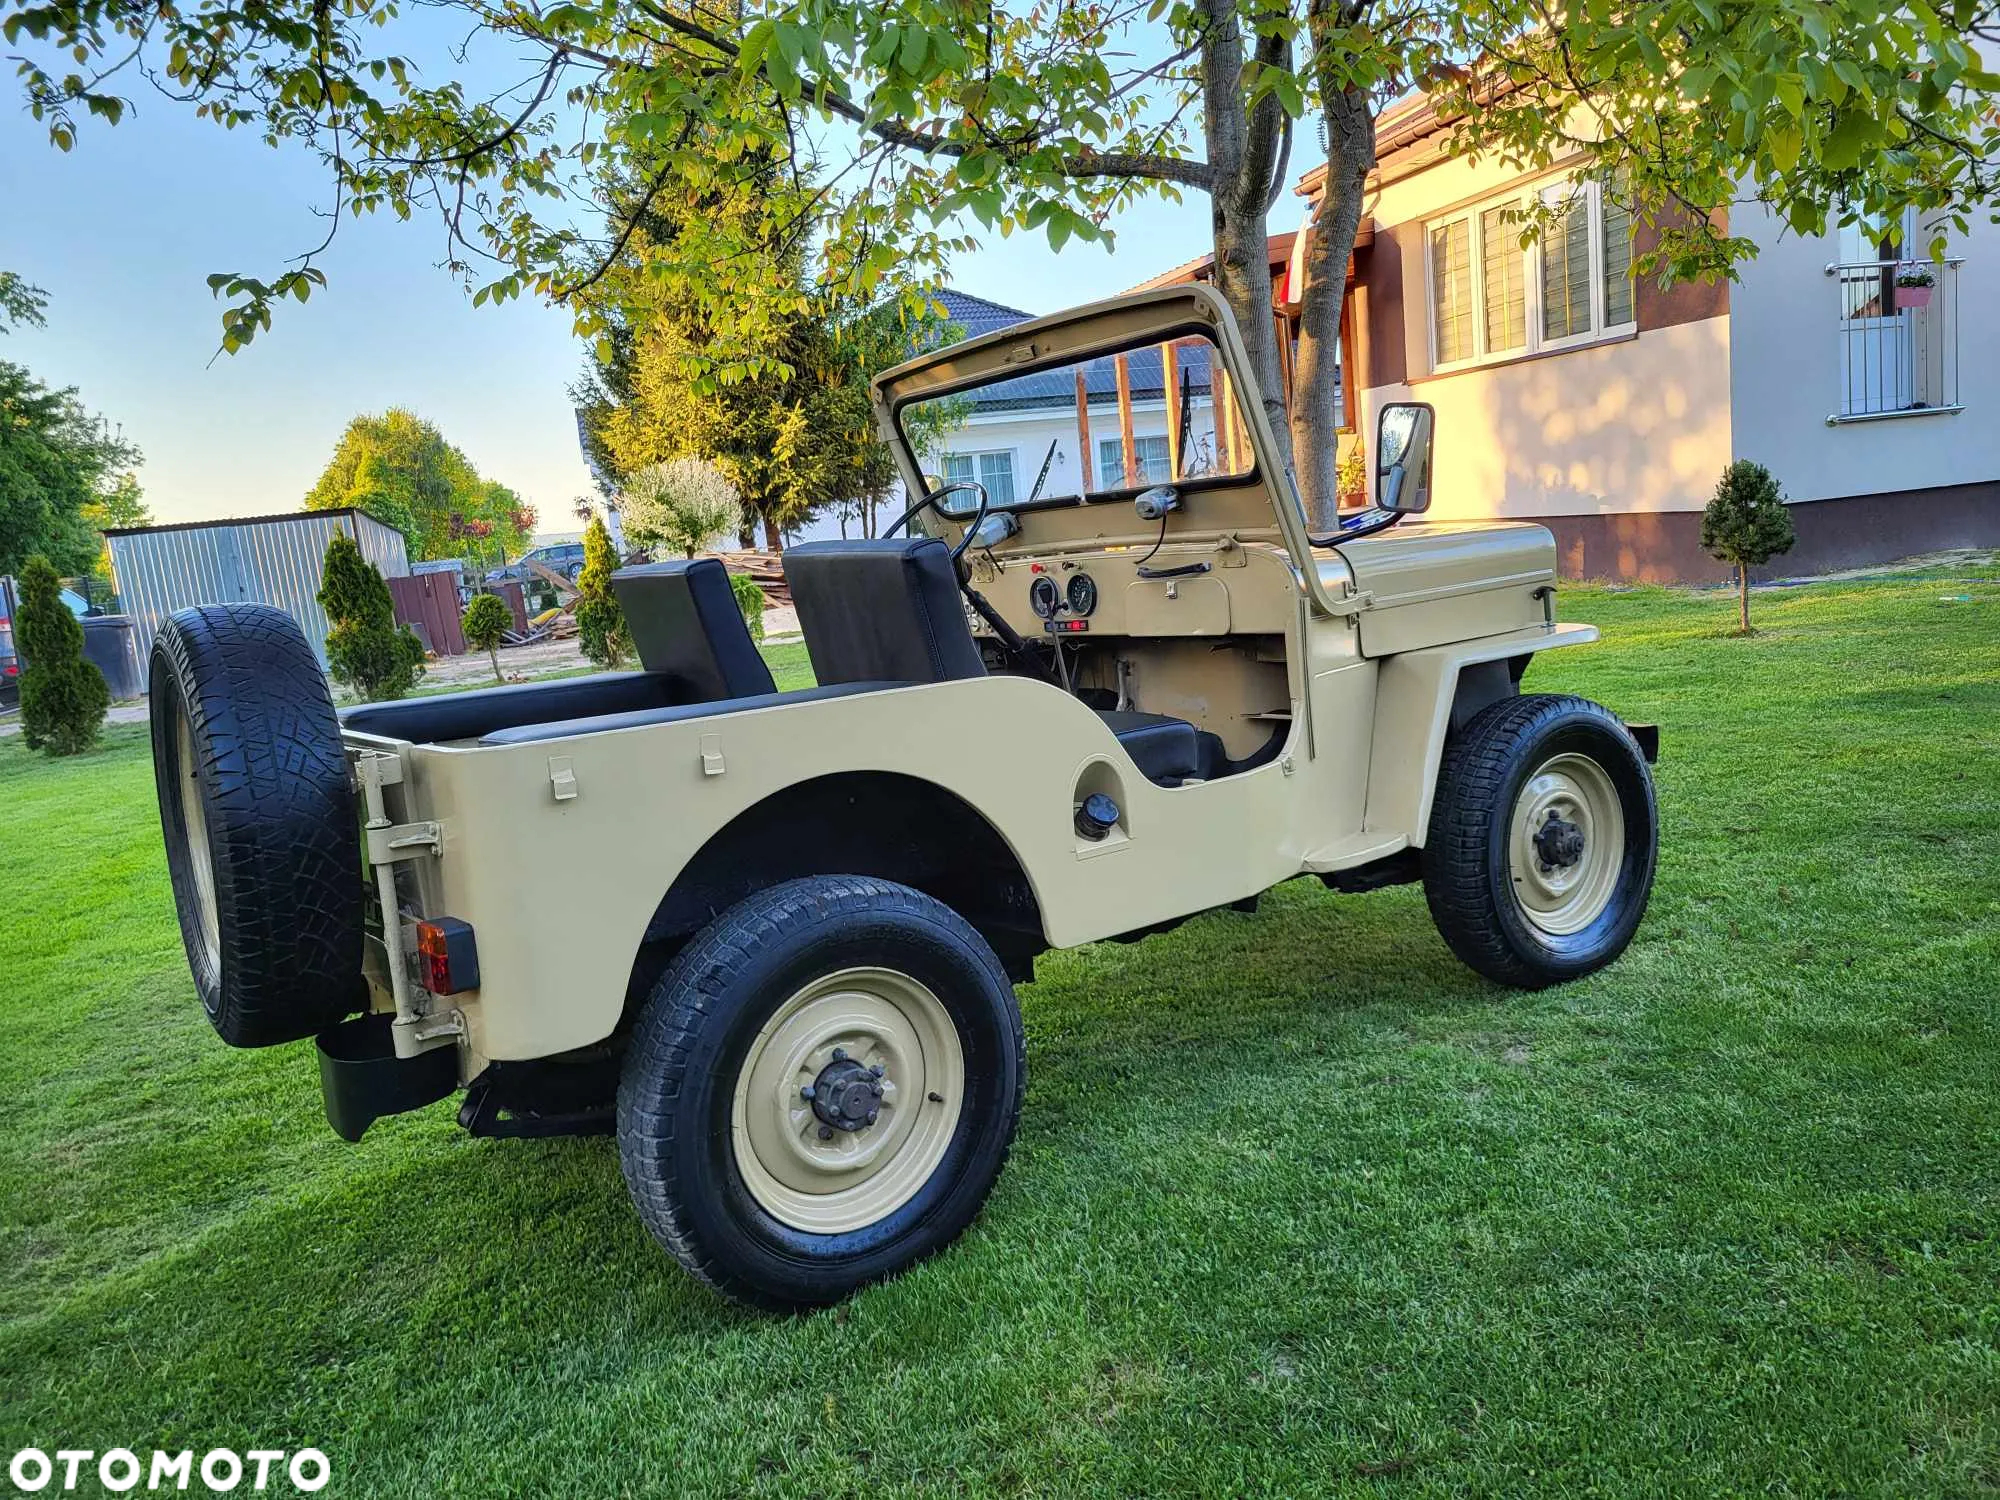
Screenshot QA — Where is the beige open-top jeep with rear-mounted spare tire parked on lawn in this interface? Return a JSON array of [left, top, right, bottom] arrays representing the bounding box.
[[152, 286, 1656, 1306]]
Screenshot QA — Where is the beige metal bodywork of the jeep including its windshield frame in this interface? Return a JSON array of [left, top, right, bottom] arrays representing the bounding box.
[[344, 286, 1596, 1080]]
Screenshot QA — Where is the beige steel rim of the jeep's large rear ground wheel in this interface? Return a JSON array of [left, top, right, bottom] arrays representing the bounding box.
[[730, 968, 966, 1234]]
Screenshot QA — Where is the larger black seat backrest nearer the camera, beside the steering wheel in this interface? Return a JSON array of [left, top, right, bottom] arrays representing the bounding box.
[[784, 536, 986, 684]]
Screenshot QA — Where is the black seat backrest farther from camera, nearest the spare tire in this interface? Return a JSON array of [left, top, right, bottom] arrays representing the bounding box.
[[612, 558, 778, 702]]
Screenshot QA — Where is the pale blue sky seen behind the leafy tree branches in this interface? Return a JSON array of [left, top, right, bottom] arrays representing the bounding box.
[[0, 82, 1248, 530]]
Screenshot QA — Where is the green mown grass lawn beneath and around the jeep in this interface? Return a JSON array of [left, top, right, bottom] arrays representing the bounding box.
[[0, 574, 2000, 1500]]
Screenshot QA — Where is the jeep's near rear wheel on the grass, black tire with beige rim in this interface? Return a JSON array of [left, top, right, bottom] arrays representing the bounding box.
[[618, 876, 1022, 1308]]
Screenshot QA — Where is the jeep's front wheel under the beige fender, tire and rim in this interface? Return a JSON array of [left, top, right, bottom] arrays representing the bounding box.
[[1424, 694, 1660, 990]]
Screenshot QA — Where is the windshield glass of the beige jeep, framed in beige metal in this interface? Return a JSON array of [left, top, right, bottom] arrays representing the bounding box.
[[896, 336, 1256, 516]]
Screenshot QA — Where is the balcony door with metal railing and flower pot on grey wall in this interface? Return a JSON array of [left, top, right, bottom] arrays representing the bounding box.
[[1826, 260, 1964, 424]]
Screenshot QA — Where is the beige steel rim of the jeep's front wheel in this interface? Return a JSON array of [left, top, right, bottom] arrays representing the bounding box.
[[1508, 754, 1624, 938]]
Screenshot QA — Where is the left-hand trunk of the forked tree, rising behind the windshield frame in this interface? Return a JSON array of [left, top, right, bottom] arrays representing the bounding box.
[[1196, 0, 1292, 476]]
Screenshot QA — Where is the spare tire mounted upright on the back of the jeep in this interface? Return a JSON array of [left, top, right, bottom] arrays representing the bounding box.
[[150, 604, 366, 1046]]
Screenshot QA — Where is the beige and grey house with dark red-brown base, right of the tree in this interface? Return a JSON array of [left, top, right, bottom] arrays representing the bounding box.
[[1298, 96, 2000, 582]]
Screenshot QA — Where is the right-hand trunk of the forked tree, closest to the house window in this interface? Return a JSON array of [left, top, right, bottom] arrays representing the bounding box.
[[1292, 0, 1376, 530]]
